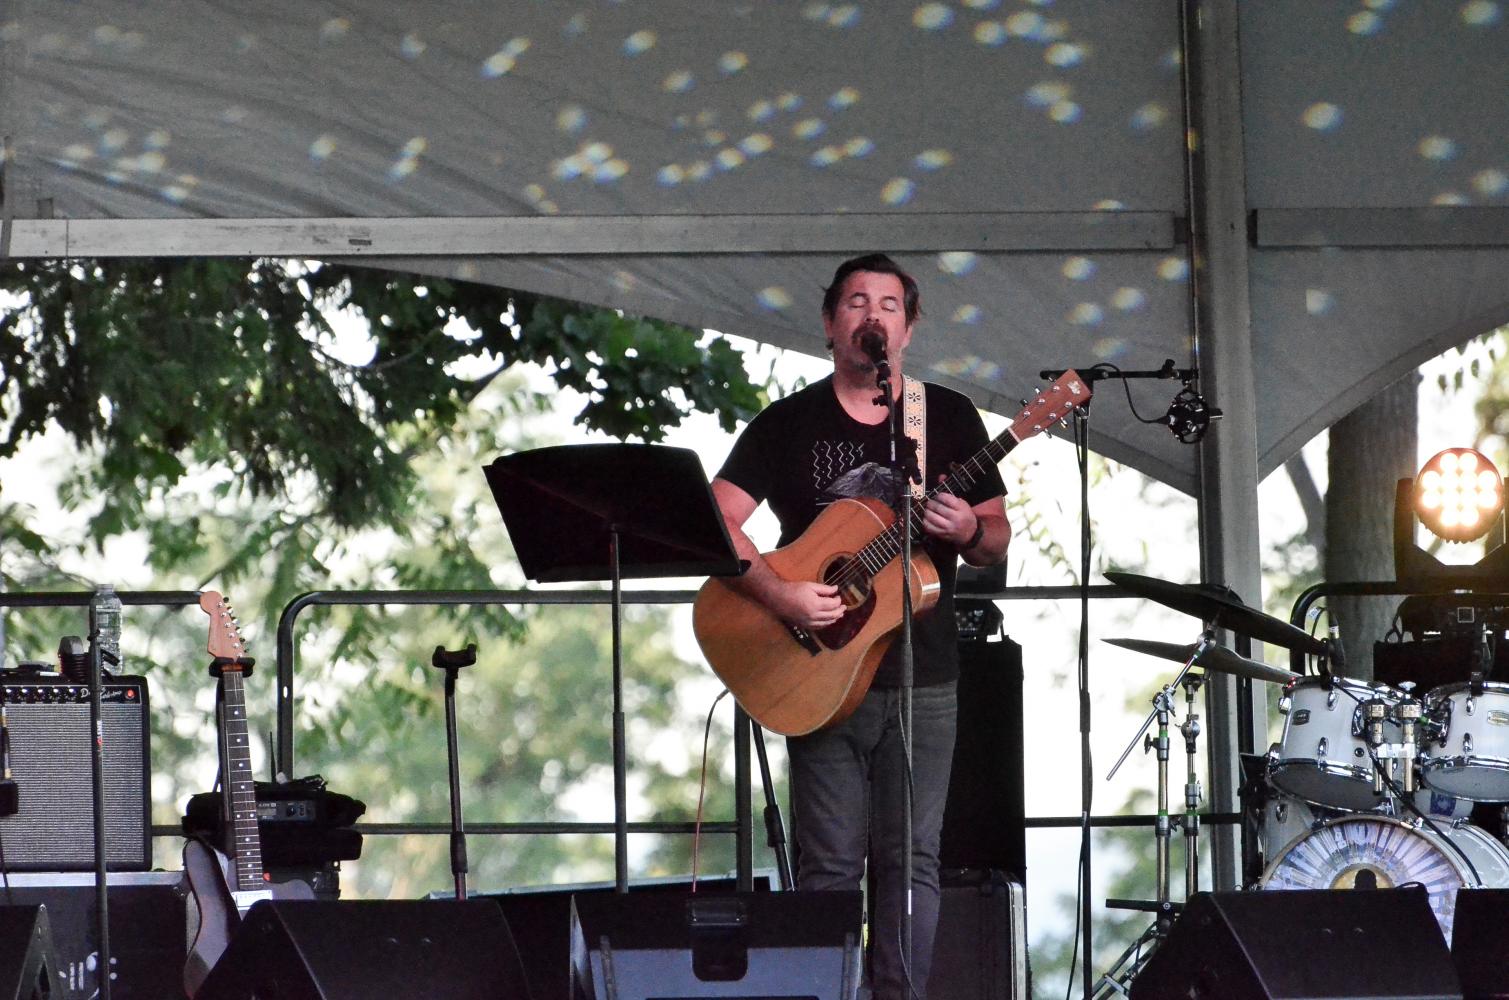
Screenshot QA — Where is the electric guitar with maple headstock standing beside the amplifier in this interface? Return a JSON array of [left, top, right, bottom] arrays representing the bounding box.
[[184, 590, 314, 997]]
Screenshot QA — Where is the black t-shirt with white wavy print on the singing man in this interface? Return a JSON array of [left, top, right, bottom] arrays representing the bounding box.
[[718, 376, 1007, 686]]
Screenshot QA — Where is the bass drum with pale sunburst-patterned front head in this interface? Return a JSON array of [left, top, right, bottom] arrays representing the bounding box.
[[1259, 816, 1509, 944]]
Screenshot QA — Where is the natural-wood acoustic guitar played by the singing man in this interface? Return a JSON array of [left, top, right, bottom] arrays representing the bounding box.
[[693, 371, 1089, 736]]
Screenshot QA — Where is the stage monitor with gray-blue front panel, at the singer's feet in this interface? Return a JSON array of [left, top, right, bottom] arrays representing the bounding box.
[[570, 891, 863, 1000]]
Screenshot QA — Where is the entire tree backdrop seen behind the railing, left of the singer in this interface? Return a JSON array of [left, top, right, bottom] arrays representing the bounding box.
[[0, 261, 764, 896]]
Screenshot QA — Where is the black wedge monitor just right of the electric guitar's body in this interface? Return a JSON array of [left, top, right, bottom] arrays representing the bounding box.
[[195, 899, 531, 1000]]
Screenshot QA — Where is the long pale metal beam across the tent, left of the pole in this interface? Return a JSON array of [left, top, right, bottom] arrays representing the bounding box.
[[8, 211, 1177, 258]]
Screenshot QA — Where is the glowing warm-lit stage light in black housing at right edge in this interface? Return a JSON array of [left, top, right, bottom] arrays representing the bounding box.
[[1394, 448, 1509, 590]]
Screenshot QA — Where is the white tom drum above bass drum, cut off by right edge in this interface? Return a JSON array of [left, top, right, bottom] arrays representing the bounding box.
[[1420, 682, 1509, 802]]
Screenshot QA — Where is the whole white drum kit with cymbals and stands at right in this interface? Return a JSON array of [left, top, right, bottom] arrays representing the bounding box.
[[1102, 573, 1509, 995]]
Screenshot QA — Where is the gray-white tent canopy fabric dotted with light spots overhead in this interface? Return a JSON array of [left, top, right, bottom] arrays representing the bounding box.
[[0, 0, 1509, 490]]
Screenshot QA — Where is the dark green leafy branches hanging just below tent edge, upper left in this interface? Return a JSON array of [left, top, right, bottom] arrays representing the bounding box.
[[0, 259, 761, 541]]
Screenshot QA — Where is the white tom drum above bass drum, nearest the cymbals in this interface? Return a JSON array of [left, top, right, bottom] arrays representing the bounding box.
[[1268, 677, 1403, 813]]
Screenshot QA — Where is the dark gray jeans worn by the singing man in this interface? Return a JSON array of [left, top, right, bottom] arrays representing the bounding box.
[[786, 683, 957, 1000]]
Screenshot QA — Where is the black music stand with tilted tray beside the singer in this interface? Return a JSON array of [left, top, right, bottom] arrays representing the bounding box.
[[483, 445, 747, 893]]
